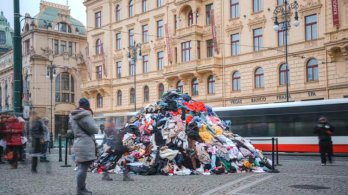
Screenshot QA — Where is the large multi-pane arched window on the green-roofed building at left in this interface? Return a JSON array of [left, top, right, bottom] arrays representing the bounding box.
[[56, 72, 75, 103]]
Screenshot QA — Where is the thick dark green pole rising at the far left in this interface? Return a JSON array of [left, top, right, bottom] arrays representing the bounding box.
[[13, 0, 23, 113]]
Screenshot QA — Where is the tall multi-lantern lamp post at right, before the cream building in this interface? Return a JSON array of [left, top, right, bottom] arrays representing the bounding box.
[[273, 0, 300, 102]]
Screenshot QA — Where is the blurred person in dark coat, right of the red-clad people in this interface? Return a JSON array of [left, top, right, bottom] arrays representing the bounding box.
[[31, 111, 44, 173]]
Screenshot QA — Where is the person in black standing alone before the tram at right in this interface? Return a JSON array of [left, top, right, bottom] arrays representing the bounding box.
[[314, 116, 334, 166]]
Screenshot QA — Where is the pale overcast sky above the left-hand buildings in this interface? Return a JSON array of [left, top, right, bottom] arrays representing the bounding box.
[[0, 0, 86, 28]]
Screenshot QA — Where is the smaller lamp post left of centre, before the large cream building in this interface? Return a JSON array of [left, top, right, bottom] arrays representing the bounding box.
[[128, 41, 142, 112]]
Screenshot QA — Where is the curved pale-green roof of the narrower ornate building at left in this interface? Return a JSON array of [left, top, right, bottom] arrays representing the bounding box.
[[34, 1, 86, 35]]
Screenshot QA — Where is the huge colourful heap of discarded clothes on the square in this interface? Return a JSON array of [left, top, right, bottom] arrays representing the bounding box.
[[95, 90, 271, 175]]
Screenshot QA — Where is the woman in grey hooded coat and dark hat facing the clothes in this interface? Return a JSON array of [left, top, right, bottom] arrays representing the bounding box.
[[69, 98, 99, 195]]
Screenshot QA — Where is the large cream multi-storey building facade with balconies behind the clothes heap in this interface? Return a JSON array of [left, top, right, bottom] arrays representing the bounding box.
[[81, 0, 348, 115]]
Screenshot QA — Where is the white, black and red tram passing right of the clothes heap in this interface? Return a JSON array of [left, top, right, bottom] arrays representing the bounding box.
[[213, 99, 348, 153]]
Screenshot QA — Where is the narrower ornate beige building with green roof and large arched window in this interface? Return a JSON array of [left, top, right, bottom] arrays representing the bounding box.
[[22, 1, 87, 138]]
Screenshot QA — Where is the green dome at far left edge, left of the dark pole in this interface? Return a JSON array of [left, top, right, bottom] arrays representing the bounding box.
[[0, 11, 13, 56]]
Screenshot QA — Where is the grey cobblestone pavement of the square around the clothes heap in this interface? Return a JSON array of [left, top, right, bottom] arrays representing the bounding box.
[[0, 151, 348, 195]]
